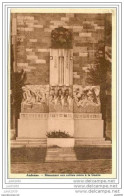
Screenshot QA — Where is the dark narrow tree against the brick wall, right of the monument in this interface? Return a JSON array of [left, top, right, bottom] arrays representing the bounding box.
[[87, 41, 111, 136]]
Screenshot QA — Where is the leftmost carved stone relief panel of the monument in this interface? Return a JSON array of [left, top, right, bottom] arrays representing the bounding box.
[[21, 85, 49, 113]]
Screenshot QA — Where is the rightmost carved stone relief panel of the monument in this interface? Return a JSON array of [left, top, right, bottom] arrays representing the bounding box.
[[73, 85, 101, 113]]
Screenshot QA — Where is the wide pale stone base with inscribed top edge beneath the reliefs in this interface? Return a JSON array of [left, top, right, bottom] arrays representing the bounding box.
[[17, 113, 108, 146]]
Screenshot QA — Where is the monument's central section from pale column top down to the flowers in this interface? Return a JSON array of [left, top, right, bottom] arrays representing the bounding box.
[[48, 49, 74, 136]]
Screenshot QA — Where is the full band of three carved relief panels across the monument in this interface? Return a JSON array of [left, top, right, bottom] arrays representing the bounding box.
[[21, 85, 101, 113]]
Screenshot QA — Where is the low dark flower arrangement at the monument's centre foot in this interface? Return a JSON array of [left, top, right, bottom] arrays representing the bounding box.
[[46, 130, 72, 138]]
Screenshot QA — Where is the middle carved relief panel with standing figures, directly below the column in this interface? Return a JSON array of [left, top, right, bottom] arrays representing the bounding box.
[[49, 86, 73, 112]]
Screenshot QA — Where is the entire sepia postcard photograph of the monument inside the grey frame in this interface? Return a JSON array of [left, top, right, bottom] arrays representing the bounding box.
[[8, 8, 112, 177]]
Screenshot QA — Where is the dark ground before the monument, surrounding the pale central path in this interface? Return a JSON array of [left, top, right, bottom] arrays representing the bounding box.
[[11, 147, 112, 174]]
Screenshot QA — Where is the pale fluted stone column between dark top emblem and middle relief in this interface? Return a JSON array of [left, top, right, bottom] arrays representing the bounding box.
[[50, 49, 73, 86]]
